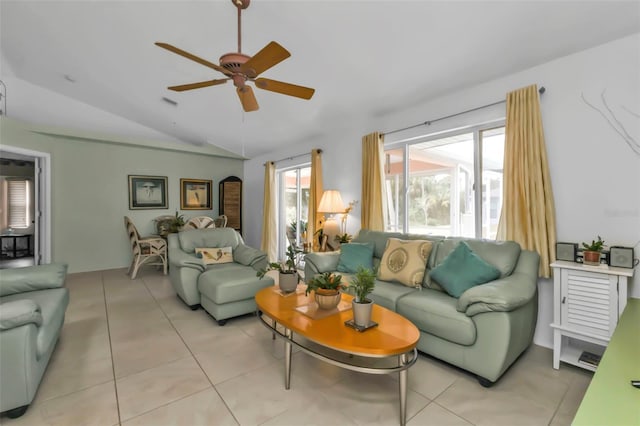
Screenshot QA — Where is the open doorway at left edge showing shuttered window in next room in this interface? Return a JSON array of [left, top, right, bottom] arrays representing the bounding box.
[[0, 145, 51, 268]]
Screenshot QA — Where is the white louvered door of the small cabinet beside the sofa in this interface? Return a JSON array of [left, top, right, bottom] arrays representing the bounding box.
[[561, 269, 618, 337]]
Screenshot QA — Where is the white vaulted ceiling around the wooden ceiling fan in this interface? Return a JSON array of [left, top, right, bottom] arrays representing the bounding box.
[[0, 0, 640, 157]]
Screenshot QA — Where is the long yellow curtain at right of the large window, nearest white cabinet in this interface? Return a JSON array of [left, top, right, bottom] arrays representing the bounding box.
[[498, 85, 556, 278]]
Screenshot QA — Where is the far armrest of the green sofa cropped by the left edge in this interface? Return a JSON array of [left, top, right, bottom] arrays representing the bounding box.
[[0, 263, 67, 296]]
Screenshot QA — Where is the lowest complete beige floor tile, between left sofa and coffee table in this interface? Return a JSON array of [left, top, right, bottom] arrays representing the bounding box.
[[116, 357, 211, 421]]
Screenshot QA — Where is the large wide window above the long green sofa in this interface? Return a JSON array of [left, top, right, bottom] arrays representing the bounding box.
[[385, 123, 504, 239]]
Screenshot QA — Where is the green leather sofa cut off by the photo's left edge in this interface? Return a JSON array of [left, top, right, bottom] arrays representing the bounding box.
[[0, 264, 69, 418]]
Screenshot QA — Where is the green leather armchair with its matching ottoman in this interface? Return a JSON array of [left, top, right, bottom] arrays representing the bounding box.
[[168, 228, 274, 325]]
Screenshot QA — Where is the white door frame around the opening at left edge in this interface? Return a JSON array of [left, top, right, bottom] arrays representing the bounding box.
[[0, 145, 51, 265]]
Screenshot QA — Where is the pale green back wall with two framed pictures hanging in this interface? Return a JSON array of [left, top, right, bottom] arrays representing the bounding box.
[[0, 118, 243, 272]]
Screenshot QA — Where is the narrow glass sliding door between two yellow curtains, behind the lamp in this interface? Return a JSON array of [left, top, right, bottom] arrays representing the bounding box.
[[278, 165, 311, 259]]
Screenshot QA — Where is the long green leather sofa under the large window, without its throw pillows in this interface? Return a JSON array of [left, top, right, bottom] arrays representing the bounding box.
[[305, 230, 540, 386]]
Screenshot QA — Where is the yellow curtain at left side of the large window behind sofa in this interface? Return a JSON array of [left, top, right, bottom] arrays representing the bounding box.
[[361, 132, 384, 231]]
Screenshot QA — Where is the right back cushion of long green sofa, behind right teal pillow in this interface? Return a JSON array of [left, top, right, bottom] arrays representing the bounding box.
[[433, 237, 521, 278]]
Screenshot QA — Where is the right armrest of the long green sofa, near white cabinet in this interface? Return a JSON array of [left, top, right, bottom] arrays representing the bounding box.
[[456, 250, 540, 317]]
